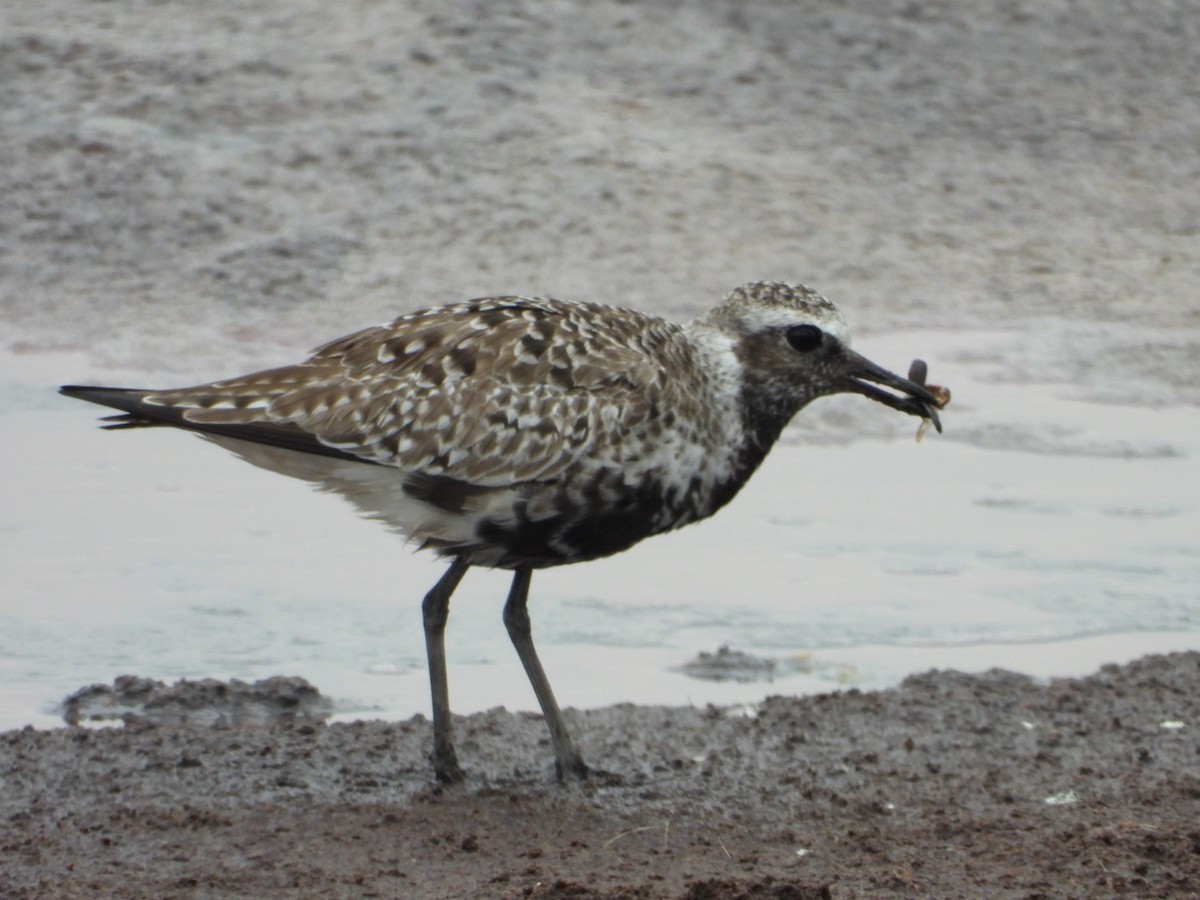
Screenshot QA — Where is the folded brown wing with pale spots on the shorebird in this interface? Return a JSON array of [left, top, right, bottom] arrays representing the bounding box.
[[142, 298, 688, 486]]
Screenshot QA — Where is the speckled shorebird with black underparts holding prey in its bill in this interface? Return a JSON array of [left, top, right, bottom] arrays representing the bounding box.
[[60, 281, 943, 784]]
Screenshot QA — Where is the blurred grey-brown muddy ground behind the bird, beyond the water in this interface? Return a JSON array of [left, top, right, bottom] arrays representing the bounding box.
[[0, 1, 1200, 381]]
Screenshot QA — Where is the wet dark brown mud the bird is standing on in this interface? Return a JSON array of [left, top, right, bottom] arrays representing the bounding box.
[[0, 653, 1200, 898]]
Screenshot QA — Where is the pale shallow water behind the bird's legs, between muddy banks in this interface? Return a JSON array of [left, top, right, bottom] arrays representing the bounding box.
[[0, 331, 1200, 727]]
